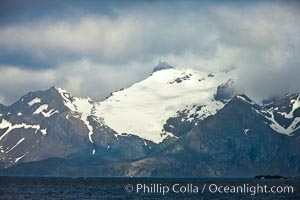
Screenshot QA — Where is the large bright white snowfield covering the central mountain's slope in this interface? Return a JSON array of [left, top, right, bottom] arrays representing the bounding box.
[[93, 62, 234, 143]]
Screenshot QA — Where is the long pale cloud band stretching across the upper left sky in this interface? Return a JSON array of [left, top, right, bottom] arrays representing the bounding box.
[[0, 13, 216, 64]]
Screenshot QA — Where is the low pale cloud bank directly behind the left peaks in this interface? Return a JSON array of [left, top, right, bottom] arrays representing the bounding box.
[[0, 59, 154, 105]]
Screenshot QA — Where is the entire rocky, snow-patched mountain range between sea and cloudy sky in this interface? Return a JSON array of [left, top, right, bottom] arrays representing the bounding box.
[[0, 62, 300, 177]]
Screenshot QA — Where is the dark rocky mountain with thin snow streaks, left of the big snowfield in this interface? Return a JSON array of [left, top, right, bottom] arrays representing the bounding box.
[[0, 87, 157, 166]]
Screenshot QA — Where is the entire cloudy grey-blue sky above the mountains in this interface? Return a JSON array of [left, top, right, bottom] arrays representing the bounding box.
[[0, 0, 300, 104]]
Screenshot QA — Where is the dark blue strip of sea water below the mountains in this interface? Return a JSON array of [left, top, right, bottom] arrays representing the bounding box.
[[0, 177, 300, 200]]
